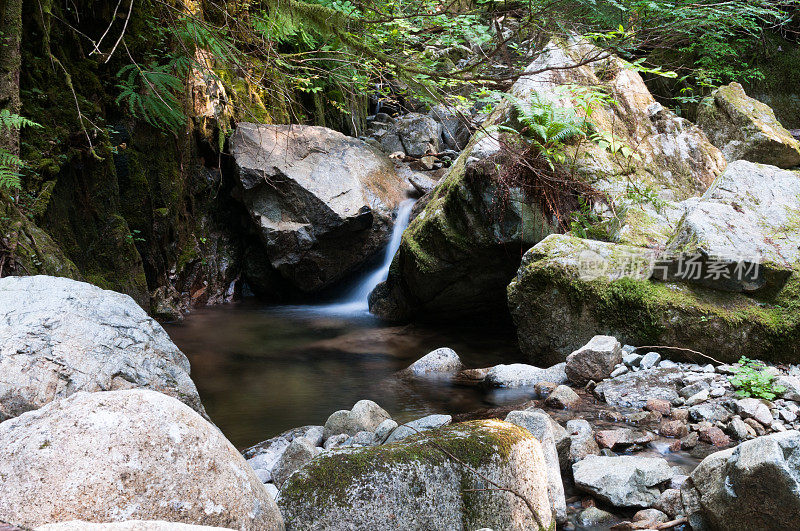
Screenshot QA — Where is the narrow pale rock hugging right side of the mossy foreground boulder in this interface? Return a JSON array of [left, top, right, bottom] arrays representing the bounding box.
[[506, 411, 567, 524]]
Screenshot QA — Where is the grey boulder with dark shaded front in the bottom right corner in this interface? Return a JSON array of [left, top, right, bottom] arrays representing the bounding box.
[[681, 431, 800, 530]]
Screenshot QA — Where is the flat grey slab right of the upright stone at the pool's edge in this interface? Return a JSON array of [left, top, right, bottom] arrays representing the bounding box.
[[595, 368, 680, 408]]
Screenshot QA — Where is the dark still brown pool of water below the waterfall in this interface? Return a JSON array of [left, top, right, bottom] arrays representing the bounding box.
[[165, 301, 530, 448]]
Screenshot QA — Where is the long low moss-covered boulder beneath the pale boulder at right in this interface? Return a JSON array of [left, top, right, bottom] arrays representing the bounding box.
[[508, 235, 800, 363]]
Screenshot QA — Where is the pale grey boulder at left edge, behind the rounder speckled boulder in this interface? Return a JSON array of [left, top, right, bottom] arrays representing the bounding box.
[[0, 276, 205, 422]]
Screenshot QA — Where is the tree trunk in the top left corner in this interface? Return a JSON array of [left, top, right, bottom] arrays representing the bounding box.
[[0, 0, 22, 155]]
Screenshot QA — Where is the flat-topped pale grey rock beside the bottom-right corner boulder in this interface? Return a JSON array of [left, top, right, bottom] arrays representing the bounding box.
[[572, 456, 673, 507]]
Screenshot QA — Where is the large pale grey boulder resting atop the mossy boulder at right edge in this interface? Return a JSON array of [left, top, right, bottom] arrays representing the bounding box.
[[668, 160, 800, 293]]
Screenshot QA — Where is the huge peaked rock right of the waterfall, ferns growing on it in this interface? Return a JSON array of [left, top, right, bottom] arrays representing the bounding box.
[[371, 41, 725, 320]]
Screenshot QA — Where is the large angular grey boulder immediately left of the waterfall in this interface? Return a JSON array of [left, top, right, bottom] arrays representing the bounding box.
[[231, 123, 405, 292]]
